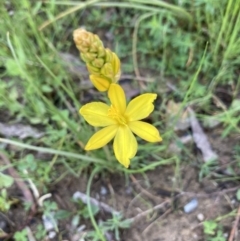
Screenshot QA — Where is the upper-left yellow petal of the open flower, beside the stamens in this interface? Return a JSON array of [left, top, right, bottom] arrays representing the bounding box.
[[79, 102, 117, 127]]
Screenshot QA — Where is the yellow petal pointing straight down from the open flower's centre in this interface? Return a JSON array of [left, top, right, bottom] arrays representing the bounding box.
[[113, 126, 138, 168]]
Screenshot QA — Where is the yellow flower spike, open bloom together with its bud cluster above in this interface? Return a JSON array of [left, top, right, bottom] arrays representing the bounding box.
[[73, 29, 162, 168]]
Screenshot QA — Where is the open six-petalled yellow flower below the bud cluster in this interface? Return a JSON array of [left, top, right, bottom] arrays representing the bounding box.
[[79, 84, 162, 168]]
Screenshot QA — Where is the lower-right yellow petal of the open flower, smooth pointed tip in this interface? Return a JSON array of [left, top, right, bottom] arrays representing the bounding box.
[[128, 121, 162, 142]]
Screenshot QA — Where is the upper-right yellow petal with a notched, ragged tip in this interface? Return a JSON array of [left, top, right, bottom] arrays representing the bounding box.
[[125, 93, 157, 121]]
